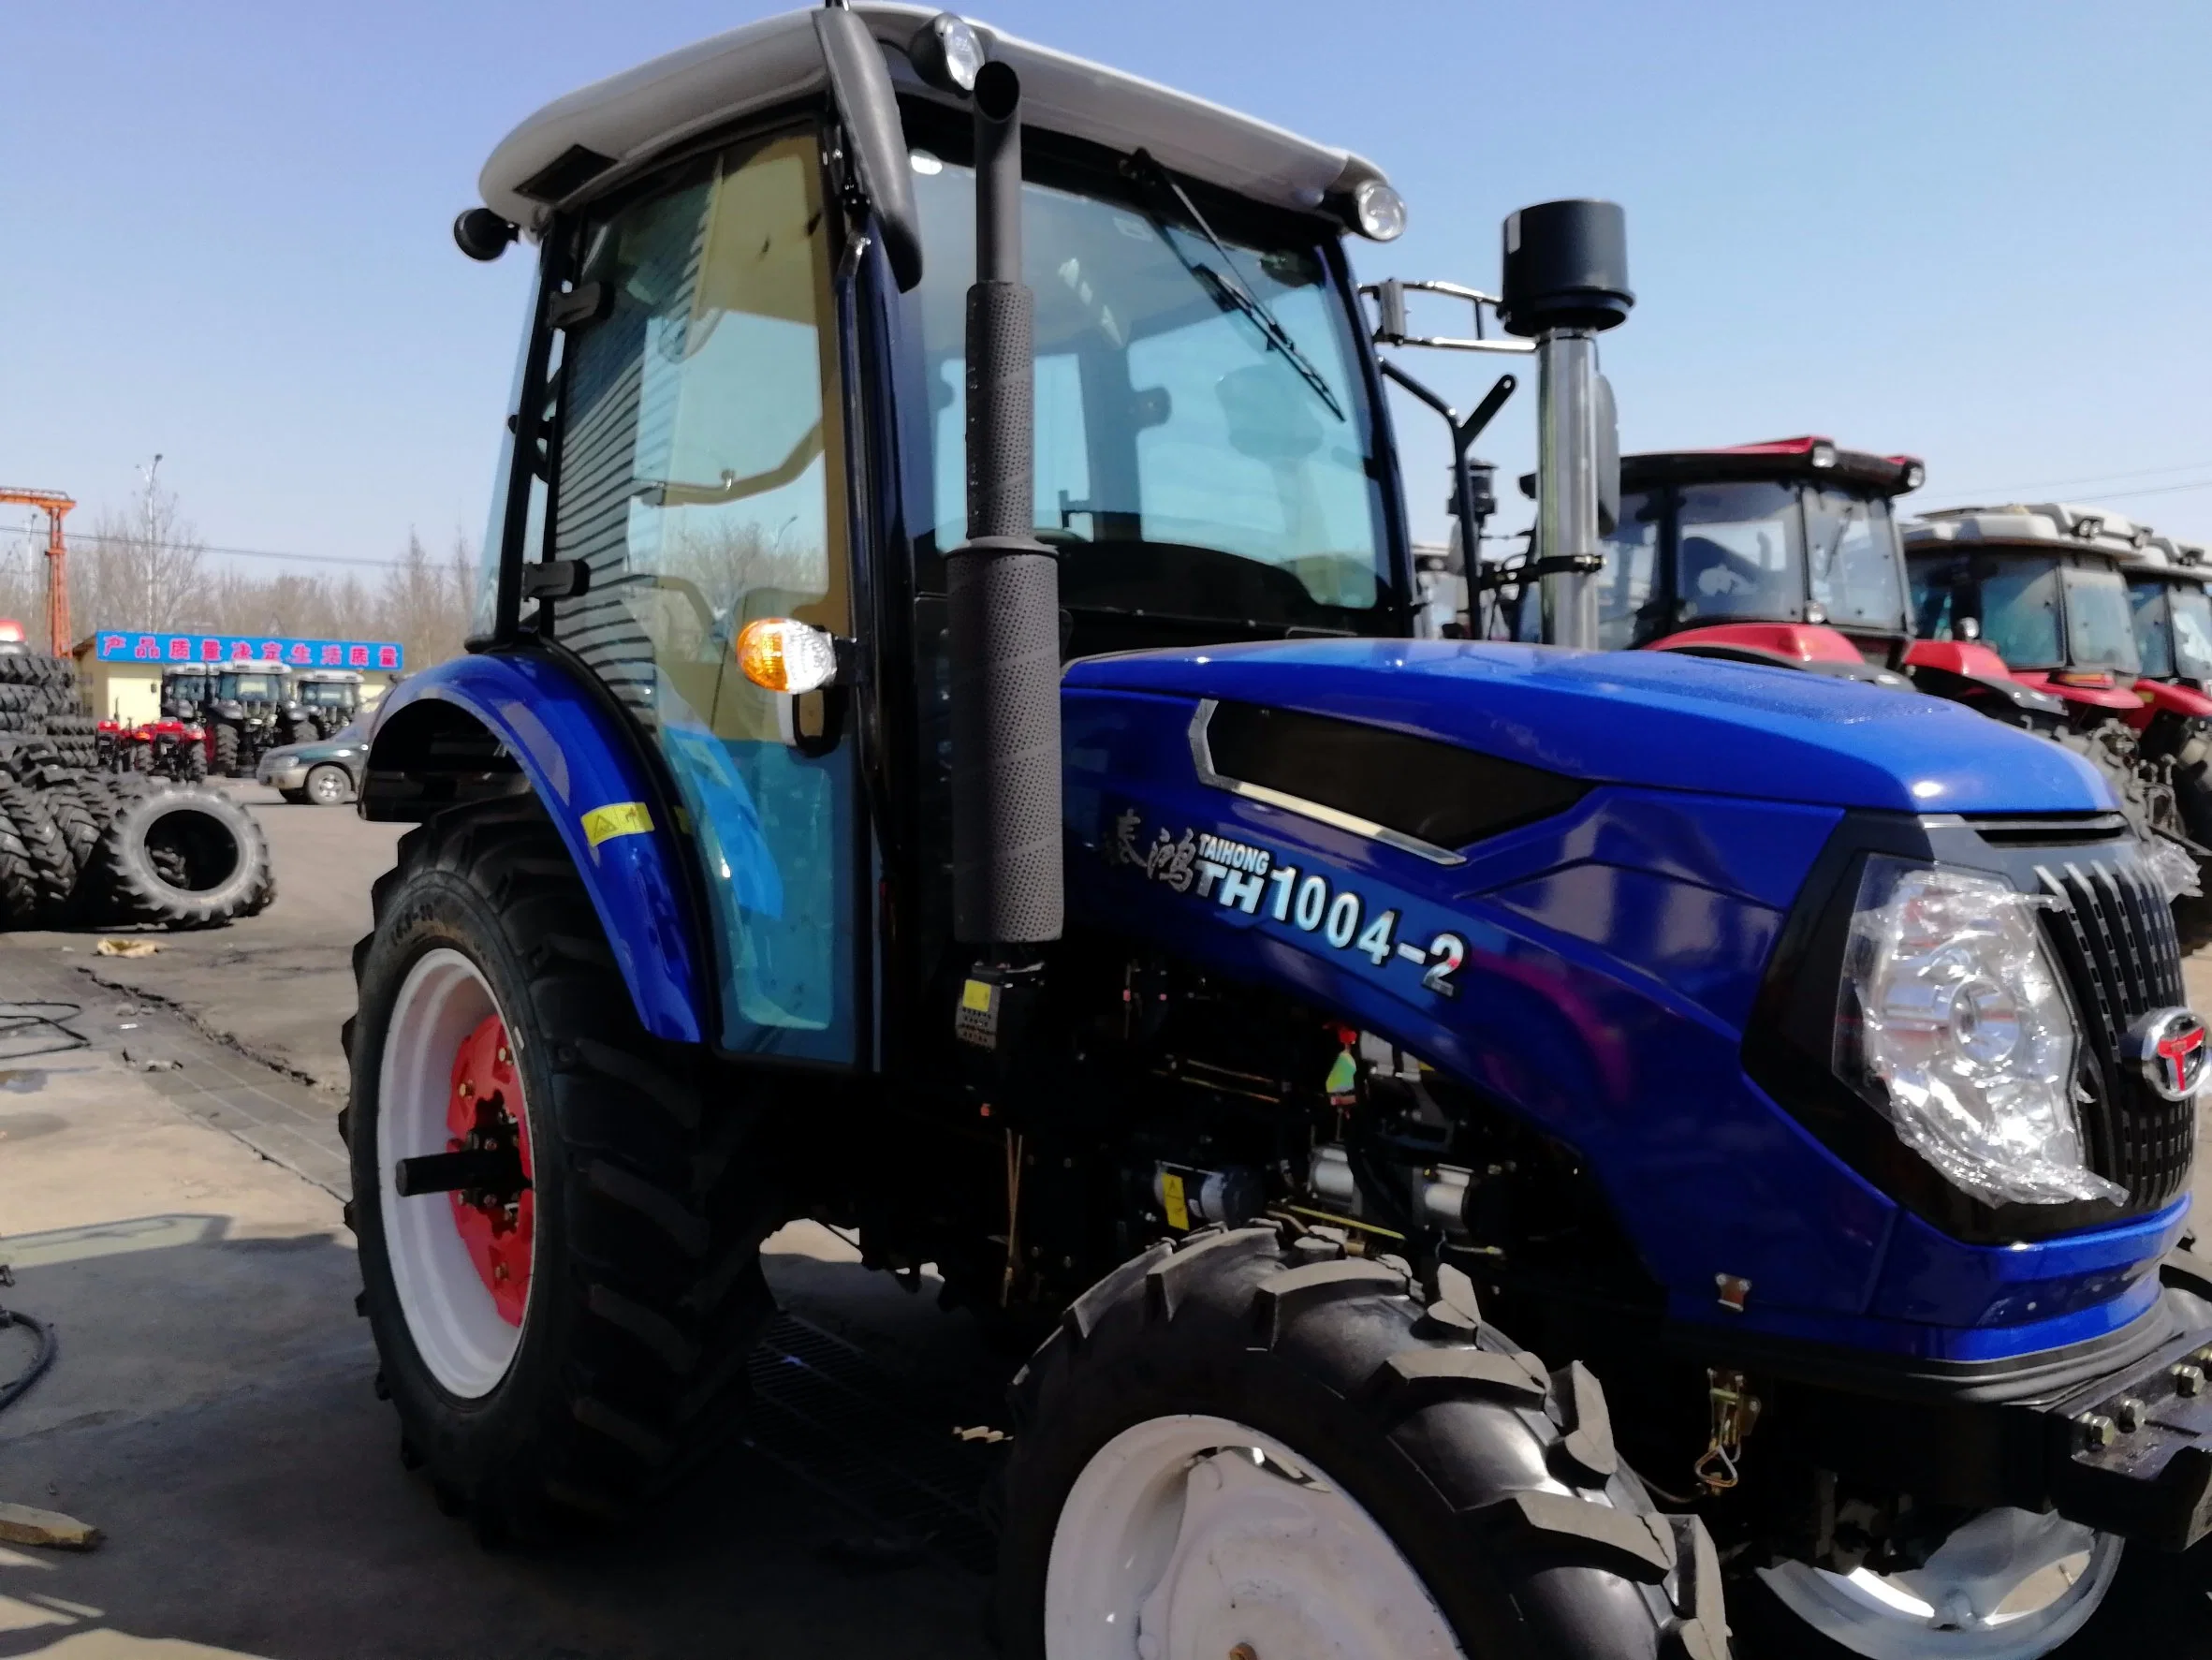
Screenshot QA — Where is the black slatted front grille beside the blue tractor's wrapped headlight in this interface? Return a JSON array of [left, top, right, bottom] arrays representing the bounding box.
[[2035, 859, 2196, 1211]]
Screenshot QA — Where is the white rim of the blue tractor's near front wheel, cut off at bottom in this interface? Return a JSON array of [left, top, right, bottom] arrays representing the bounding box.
[[1044, 1417, 1460, 1660]]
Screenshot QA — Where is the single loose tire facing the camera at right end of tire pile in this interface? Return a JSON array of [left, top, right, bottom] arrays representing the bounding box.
[[95, 786, 270, 928]]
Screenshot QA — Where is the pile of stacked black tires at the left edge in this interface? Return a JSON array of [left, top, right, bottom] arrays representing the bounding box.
[[0, 655, 276, 928]]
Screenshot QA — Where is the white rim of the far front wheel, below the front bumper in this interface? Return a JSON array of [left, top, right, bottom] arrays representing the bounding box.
[[1759, 1509, 2121, 1660]]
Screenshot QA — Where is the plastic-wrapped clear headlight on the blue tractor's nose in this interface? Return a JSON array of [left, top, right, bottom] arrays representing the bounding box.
[[1836, 859, 2128, 1204]]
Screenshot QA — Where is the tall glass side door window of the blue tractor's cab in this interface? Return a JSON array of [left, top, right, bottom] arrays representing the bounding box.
[[553, 133, 854, 1060]]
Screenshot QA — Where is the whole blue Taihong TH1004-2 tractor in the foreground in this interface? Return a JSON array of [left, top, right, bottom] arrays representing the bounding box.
[[347, 5, 2212, 1660]]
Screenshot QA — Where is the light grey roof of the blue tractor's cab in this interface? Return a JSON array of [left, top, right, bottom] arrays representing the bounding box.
[[477, 5, 1383, 232]]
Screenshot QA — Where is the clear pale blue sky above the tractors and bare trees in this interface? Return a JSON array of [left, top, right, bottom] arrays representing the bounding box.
[[0, 0, 2212, 569]]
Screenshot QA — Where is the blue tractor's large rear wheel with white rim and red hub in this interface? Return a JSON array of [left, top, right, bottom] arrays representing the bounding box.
[[341, 801, 784, 1538]]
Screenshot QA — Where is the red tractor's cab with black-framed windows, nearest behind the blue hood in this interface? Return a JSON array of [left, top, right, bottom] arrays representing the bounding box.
[[1516, 436, 1922, 680]]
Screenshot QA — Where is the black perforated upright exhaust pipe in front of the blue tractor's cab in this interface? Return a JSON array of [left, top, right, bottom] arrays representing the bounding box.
[[945, 62, 1064, 956]]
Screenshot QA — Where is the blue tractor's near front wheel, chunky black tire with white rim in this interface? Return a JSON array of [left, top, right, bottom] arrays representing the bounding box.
[[998, 1227, 1728, 1660]]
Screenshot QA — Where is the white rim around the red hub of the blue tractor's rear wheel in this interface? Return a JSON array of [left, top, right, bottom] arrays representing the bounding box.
[[376, 948, 529, 1401]]
